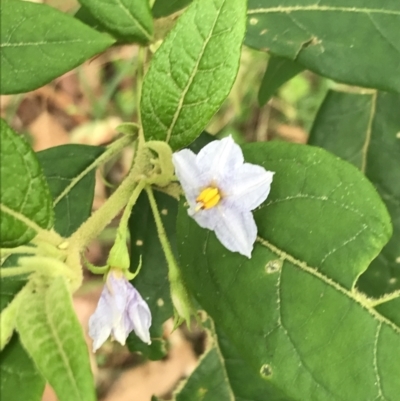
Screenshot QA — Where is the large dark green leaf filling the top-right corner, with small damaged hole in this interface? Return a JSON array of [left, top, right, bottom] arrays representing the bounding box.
[[246, 0, 400, 92]]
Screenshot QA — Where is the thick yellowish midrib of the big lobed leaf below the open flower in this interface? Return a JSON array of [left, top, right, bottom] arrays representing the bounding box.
[[257, 236, 400, 334]]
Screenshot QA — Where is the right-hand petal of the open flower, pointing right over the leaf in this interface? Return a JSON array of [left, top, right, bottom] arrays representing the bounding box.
[[221, 163, 274, 210]]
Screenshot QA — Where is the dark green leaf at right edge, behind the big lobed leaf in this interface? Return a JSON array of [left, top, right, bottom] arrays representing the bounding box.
[[309, 91, 400, 297]]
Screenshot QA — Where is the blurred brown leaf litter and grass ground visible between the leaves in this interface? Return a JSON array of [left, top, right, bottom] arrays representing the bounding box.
[[1, 0, 346, 401]]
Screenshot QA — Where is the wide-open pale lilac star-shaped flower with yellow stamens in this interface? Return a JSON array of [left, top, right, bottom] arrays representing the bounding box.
[[172, 136, 274, 258]]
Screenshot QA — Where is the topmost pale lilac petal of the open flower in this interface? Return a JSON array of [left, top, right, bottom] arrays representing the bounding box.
[[196, 135, 244, 185]]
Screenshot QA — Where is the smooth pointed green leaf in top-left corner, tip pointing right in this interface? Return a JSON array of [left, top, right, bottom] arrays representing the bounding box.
[[0, 1, 114, 94]]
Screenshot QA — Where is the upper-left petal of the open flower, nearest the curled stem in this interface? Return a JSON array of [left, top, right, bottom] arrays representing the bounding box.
[[172, 149, 206, 205]]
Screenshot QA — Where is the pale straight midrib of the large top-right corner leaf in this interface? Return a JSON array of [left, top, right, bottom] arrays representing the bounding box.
[[247, 5, 400, 16]]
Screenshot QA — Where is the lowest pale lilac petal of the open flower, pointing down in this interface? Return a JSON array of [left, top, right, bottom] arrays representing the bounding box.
[[214, 206, 257, 258]]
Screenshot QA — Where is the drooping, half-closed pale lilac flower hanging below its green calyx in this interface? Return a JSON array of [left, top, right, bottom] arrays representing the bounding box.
[[89, 270, 151, 352]]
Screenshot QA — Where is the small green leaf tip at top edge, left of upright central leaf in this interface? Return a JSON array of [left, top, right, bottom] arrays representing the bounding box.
[[79, 0, 153, 43]]
